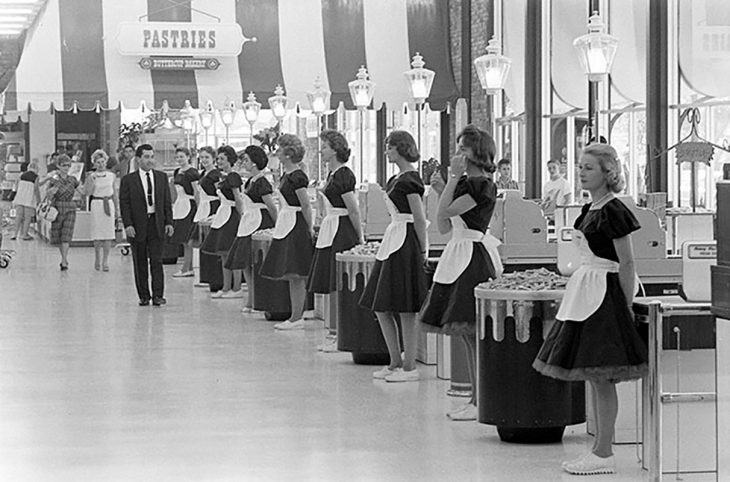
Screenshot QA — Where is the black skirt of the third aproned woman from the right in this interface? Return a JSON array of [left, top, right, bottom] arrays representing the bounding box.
[[359, 223, 428, 313]]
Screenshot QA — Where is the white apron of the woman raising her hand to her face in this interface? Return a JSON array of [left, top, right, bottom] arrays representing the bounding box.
[[433, 216, 503, 285]]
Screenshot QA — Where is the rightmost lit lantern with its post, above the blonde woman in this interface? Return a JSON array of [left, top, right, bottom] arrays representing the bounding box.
[[573, 12, 618, 141]]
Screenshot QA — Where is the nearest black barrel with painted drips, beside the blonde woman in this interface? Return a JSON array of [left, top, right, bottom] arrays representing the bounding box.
[[474, 285, 585, 443]]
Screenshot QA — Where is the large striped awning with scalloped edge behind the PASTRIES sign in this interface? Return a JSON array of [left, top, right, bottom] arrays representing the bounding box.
[[5, 0, 458, 110]]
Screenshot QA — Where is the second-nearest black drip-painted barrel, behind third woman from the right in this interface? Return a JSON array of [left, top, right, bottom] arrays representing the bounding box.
[[336, 253, 390, 365]]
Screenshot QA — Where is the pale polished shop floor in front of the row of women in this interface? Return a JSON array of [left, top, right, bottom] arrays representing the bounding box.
[[0, 238, 715, 482]]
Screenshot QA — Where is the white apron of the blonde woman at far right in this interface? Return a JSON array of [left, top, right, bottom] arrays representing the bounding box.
[[556, 229, 619, 321]]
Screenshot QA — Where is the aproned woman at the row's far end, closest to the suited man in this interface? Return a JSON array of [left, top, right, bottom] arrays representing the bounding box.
[[168, 147, 200, 278]]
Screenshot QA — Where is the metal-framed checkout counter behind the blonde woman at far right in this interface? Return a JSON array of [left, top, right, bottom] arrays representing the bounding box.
[[634, 296, 716, 481]]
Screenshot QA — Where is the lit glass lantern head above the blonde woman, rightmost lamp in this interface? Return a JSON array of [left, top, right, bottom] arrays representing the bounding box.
[[573, 12, 618, 82]]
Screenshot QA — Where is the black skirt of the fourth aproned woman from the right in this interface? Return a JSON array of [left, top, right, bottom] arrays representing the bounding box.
[[307, 216, 358, 294]]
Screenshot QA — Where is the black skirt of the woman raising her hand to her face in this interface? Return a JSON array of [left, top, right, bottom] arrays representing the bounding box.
[[418, 243, 495, 335]]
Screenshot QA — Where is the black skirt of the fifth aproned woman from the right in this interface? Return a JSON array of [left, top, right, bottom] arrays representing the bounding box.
[[259, 211, 314, 279]]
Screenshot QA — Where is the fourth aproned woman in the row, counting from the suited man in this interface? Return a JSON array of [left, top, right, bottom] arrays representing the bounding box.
[[224, 146, 277, 313]]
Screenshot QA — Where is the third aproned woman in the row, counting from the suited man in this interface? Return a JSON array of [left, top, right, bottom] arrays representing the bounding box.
[[200, 146, 243, 299]]
